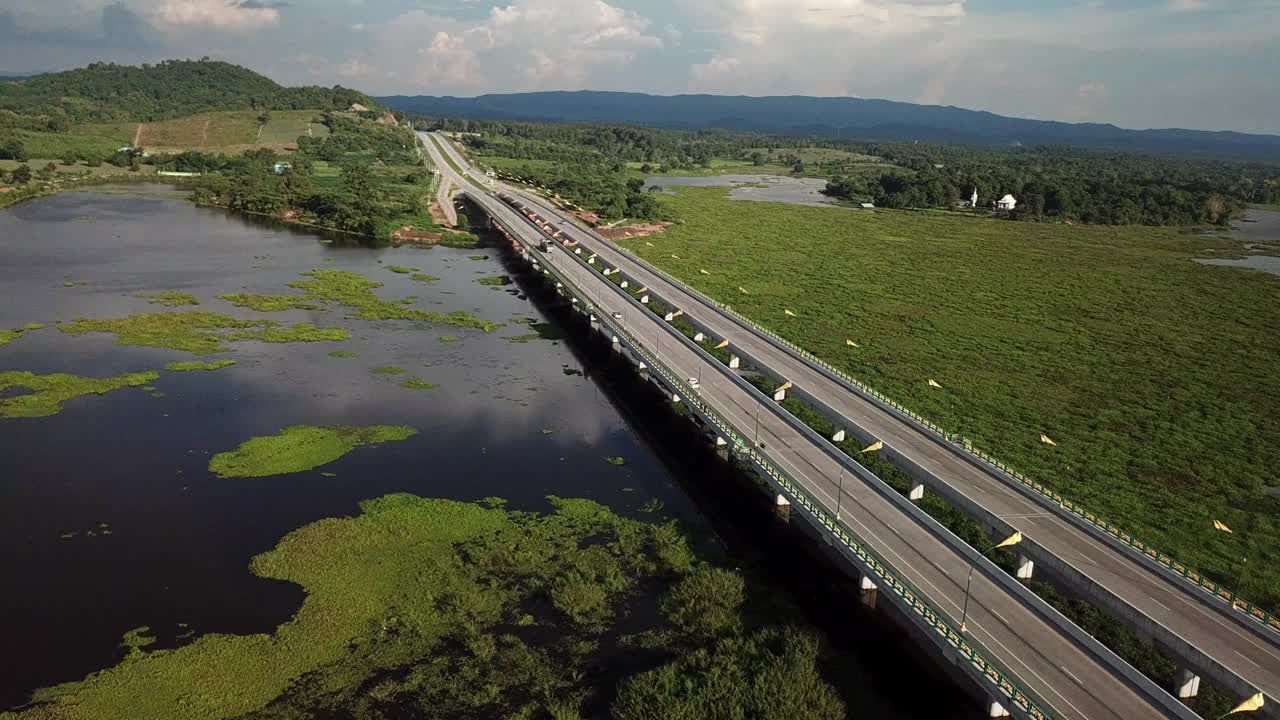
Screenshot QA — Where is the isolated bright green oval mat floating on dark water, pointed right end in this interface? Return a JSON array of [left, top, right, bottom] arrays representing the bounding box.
[[209, 425, 417, 478]]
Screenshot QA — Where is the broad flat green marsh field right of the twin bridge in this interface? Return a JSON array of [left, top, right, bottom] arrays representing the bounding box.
[[630, 188, 1280, 607]]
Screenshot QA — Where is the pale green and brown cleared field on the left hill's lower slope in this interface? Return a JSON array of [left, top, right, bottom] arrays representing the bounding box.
[[77, 110, 329, 151]]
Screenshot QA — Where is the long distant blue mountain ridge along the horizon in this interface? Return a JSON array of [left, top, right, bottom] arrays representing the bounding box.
[[378, 91, 1280, 160]]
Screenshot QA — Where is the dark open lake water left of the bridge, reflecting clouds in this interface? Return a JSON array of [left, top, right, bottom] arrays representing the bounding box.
[[0, 192, 960, 717]]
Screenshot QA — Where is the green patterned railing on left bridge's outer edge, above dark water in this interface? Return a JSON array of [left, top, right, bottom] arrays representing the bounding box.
[[481, 204, 1055, 720]]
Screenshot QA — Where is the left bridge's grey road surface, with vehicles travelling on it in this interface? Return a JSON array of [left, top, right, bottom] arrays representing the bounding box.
[[424, 130, 1198, 720]]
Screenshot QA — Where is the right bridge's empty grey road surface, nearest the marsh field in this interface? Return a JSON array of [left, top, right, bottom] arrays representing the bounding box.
[[435, 131, 1280, 698]]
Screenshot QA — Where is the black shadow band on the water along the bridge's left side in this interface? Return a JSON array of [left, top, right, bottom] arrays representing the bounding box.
[[467, 204, 980, 720]]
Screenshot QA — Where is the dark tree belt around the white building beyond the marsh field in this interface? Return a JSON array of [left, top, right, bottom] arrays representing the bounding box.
[[826, 145, 1280, 225]]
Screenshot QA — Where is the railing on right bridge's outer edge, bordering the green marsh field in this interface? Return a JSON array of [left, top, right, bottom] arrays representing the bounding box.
[[599, 245, 1280, 633]]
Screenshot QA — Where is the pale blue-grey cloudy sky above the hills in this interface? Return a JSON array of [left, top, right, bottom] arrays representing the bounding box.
[[0, 0, 1280, 135]]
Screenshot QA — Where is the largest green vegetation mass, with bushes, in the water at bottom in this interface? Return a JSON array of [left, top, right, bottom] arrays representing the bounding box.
[[3, 495, 845, 720]]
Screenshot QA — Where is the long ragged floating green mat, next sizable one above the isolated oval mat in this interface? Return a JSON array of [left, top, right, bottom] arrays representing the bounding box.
[[59, 310, 351, 355]]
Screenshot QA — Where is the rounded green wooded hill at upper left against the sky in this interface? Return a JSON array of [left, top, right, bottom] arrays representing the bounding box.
[[0, 60, 376, 127]]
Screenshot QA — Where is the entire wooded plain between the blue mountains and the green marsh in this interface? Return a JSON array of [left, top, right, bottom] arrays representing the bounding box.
[[420, 118, 1280, 225]]
